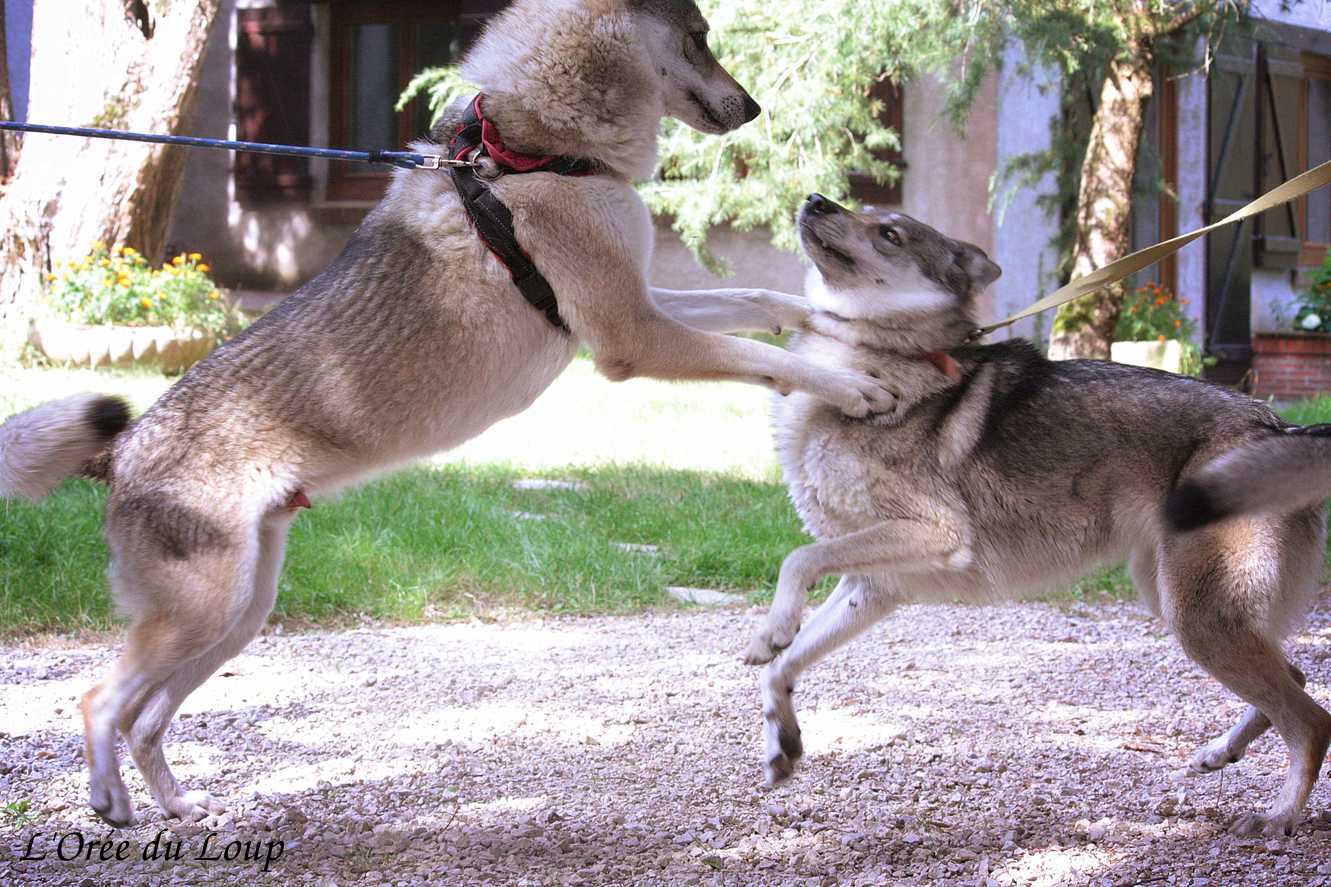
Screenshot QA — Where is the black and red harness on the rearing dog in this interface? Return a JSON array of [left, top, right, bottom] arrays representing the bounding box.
[[449, 96, 602, 333]]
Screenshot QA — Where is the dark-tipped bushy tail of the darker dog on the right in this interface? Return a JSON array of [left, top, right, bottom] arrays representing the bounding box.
[[1165, 425, 1331, 531]]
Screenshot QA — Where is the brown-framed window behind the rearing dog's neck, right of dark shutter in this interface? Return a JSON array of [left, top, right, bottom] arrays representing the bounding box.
[[327, 0, 504, 200]]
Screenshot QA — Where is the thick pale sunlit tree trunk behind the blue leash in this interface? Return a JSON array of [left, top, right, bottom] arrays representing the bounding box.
[[0, 0, 220, 351]]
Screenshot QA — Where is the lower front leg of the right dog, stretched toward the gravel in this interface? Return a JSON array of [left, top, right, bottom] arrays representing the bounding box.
[[761, 575, 898, 784]]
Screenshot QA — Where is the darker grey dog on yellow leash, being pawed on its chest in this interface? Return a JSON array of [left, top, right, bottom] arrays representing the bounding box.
[[747, 196, 1331, 834]]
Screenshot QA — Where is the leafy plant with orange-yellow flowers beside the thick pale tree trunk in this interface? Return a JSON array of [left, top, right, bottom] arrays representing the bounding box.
[[47, 242, 241, 338]]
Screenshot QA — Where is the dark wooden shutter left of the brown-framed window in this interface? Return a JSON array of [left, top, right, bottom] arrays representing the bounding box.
[[234, 3, 313, 205]]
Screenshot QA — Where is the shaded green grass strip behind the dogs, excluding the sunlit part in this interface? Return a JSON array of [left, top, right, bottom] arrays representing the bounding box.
[[0, 466, 805, 634]]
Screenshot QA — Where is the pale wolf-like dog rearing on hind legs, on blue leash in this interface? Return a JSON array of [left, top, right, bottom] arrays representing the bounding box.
[[0, 0, 893, 824]]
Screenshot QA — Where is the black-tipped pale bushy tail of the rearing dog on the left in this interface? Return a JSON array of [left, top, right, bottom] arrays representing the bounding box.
[[0, 394, 129, 502]]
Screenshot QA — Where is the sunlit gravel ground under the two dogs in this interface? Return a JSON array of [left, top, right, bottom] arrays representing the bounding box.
[[0, 598, 1331, 887]]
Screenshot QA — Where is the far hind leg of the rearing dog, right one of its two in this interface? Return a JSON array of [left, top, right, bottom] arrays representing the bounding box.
[[122, 510, 294, 819]]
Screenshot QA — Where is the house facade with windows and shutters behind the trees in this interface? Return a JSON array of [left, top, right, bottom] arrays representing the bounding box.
[[5, 0, 1331, 378]]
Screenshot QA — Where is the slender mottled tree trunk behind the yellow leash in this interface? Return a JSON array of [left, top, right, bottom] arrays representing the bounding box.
[[1049, 47, 1153, 360]]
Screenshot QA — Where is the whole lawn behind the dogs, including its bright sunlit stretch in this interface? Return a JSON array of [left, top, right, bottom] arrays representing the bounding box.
[[0, 361, 1331, 635]]
